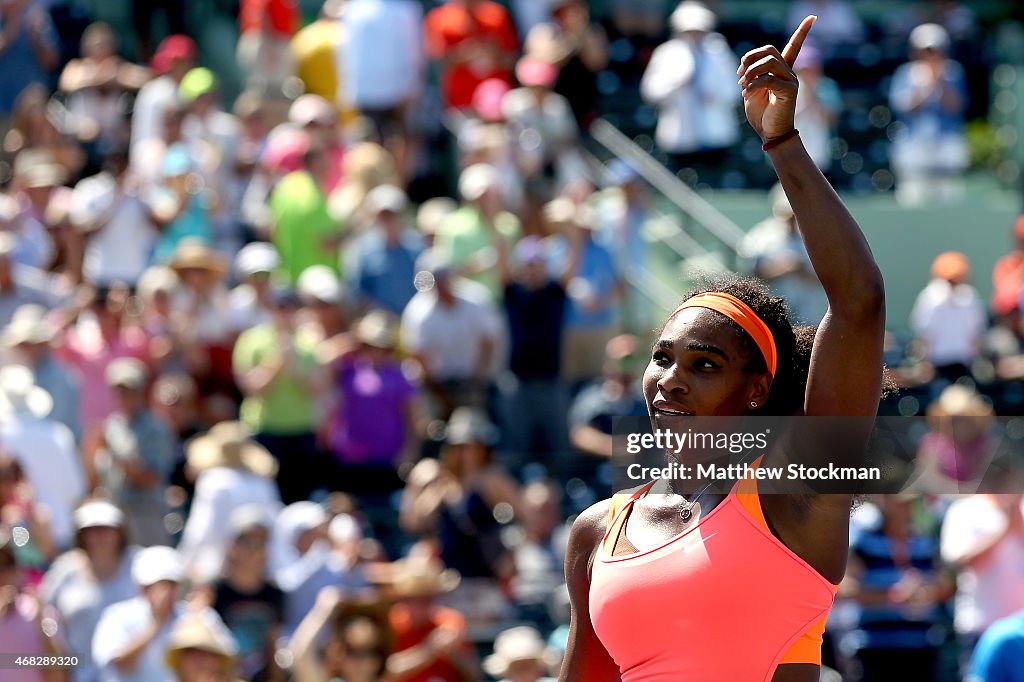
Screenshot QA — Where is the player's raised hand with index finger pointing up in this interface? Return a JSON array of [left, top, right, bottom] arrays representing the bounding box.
[[736, 15, 817, 140]]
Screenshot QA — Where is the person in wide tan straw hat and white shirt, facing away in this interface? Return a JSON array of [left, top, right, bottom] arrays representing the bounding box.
[[178, 422, 282, 583]]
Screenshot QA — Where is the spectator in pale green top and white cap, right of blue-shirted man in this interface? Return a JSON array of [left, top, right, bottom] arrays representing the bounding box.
[[434, 164, 520, 302]]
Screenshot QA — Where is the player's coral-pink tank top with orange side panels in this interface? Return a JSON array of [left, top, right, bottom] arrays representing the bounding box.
[[590, 460, 838, 682]]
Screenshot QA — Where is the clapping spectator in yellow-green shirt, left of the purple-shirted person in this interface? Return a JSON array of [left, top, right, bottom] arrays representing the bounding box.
[[232, 287, 324, 504]]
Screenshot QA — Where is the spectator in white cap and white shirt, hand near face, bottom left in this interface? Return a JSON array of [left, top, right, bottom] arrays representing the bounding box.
[[92, 546, 194, 682]]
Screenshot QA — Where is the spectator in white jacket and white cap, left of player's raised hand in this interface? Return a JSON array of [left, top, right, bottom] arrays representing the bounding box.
[[640, 0, 740, 177]]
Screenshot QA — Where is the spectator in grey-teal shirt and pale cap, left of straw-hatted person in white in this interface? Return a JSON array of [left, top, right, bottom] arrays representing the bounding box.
[[83, 357, 175, 547]]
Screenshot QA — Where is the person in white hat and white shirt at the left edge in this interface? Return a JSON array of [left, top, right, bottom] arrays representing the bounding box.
[[0, 365, 86, 548]]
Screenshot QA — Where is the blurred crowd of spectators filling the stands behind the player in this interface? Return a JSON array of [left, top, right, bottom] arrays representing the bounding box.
[[0, 0, 1024, 682]]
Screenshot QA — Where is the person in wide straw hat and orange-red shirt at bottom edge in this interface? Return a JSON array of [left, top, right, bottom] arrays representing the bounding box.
[[387, 559, 481, 682]]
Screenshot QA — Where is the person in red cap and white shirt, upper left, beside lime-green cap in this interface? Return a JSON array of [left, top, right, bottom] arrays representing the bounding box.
[[131, 34, 198, 170]]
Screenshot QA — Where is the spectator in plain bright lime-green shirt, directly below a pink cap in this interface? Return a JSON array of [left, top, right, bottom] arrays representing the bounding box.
[[269, 140, 343, 286]]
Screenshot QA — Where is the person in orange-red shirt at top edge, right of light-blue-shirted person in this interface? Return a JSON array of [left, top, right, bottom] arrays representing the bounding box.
[[425, 0, 519, 109]]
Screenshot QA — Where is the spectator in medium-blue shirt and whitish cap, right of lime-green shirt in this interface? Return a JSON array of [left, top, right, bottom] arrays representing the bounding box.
[[345, 184, 424, 314]]
